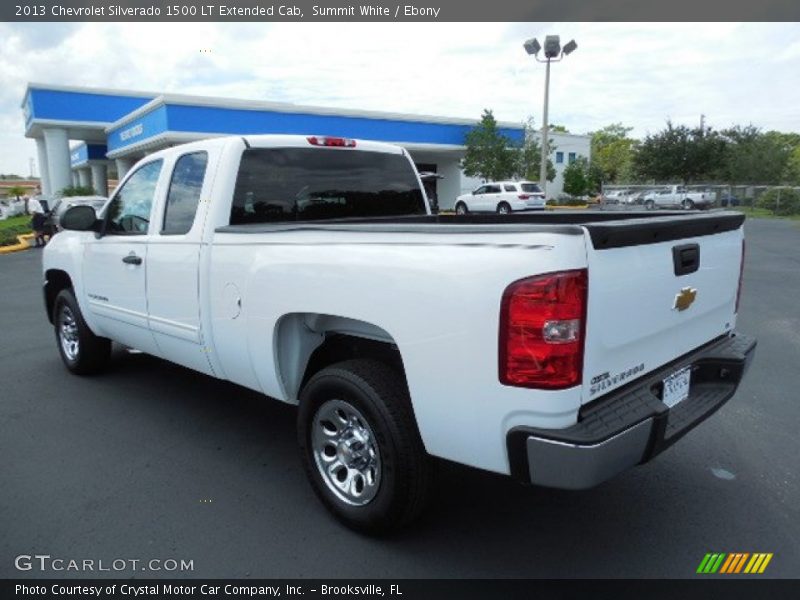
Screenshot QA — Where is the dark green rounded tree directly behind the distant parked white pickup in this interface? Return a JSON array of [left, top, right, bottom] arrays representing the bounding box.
[[634, 121, 726, 184]]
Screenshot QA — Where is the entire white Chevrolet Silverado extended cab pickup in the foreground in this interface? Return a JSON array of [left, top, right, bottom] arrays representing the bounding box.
[[44, 136, 755, 531]]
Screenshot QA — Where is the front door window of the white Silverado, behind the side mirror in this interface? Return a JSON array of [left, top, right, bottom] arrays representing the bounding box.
[[106, 160, 164, 235]]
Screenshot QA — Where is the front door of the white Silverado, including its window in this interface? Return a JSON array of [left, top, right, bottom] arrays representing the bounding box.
[[83, 160, 162, 355]]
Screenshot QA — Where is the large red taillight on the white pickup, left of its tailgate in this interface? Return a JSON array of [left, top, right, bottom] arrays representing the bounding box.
[[499, 269, 588, 390]]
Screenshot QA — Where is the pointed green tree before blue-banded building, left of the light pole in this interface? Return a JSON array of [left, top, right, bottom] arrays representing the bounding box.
[[461, 109, 518, 181]]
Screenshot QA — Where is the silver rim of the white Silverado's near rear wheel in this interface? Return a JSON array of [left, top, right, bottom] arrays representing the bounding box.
[[311, 400, 381, 506]]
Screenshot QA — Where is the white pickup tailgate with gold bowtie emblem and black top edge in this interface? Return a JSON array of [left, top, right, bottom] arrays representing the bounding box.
[[582, 213, 744, 404]]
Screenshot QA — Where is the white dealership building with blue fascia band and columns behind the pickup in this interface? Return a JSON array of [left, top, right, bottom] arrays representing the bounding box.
[[22, 83, 590, 208]]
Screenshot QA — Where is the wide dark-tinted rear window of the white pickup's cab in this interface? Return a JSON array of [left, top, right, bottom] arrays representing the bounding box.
[[231, 148, 426, 225]]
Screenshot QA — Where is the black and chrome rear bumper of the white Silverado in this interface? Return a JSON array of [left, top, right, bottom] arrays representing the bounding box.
[[506, 333, 756, 490]]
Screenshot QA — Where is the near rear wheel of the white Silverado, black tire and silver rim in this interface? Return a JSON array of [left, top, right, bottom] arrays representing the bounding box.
[[297, 359, 431, 534]]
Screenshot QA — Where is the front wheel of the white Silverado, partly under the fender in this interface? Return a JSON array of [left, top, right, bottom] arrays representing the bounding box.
[[53, 289, 111, 375]]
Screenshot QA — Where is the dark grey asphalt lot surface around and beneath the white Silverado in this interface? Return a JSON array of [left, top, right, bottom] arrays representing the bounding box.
[[0, 220, 800, 578]]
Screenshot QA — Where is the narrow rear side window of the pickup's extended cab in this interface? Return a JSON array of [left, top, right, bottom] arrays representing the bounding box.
[[161, 152, 208, 235]]
